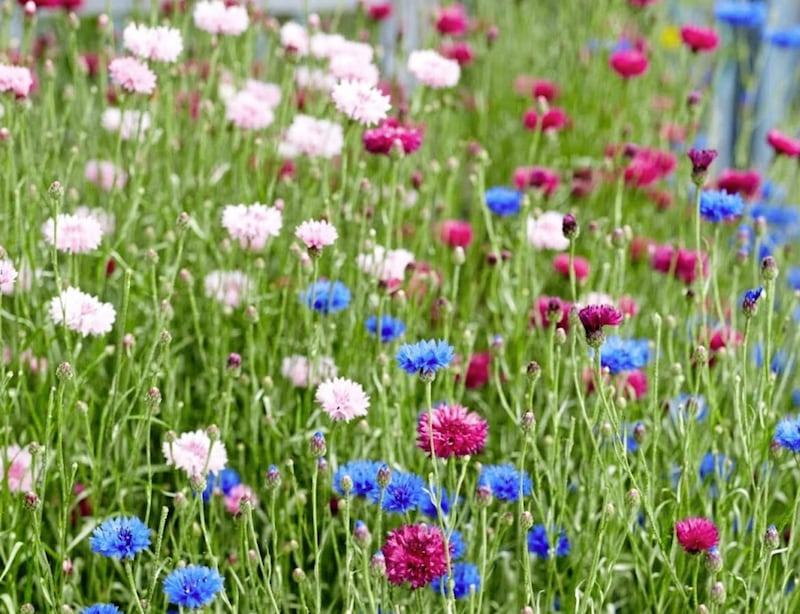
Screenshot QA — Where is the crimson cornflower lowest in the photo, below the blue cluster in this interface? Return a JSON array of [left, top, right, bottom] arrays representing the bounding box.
[[381, 524, 447, 589]]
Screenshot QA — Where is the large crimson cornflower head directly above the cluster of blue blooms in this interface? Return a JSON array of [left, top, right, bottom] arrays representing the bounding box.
[[417, 404, 489, 458]]
